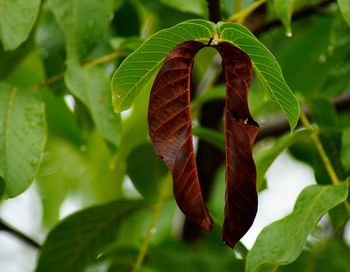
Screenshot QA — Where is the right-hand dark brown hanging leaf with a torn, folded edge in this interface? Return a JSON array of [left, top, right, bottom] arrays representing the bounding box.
[[215, 42, 259, 248]]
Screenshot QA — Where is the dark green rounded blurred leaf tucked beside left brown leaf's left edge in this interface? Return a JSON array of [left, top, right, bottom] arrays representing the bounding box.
[[126, 142, 168, 200]]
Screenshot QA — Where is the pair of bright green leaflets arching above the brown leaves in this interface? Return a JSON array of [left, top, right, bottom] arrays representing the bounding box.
[[112, 19, 300, 129]]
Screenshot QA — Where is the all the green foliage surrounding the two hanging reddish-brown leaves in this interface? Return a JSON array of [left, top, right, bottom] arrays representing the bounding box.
[[0, 0, 350, 272]]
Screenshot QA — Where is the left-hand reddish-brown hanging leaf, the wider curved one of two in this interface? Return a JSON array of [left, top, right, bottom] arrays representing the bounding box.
[[148, 41, 212, 229]]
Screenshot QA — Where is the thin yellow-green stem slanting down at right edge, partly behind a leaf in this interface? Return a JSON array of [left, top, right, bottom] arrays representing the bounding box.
[[300, 111, 350, 215]]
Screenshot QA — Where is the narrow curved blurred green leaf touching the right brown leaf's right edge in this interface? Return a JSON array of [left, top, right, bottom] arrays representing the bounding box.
[[254, 130, 311, 190]]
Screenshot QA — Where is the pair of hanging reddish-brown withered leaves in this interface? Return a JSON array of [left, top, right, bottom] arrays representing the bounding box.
[[148, 41, 258, 247]]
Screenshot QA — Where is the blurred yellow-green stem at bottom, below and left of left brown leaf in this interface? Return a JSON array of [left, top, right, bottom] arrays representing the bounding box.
[[132, 175, 171, 272]]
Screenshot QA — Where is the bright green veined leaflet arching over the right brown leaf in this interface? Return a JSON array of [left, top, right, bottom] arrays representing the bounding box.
[[218, 23, 300, 130]]
